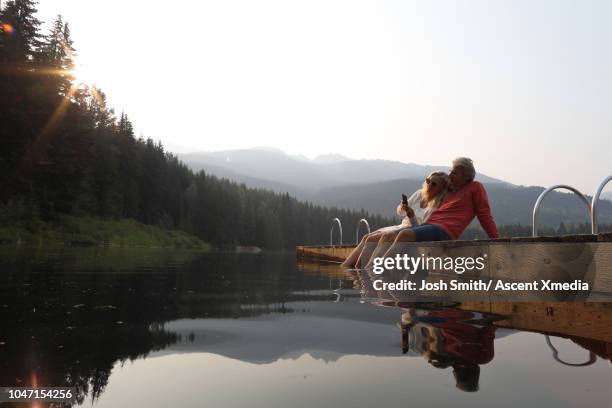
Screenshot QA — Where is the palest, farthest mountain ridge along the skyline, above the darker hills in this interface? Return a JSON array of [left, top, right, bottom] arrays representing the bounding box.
[[179, 148, 507, 192]]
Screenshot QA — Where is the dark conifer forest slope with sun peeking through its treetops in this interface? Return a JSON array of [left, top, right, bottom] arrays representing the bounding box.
[[0, 4, 393, 249]]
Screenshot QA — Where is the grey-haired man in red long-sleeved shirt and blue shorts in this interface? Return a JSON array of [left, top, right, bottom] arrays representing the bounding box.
[[395, 157, 499, 242]]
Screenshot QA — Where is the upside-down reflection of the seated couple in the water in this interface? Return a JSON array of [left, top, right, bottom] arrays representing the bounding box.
[[401, 309, 495, 392]]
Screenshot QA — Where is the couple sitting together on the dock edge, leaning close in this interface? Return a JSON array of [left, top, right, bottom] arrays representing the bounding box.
[[342, 157, 499, 268]]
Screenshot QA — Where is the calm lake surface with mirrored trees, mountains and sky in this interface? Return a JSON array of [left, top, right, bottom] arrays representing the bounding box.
[[0, 248, 612, 407]]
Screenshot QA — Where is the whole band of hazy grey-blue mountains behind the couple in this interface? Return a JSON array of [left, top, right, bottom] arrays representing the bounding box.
[[179, 148, 612, 227]]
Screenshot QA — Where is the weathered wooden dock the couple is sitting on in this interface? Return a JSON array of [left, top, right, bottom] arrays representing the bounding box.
[[296, 233, 612, 297]]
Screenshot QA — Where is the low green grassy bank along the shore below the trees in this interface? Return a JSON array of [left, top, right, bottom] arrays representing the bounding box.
[[0, 216, 210, 250]]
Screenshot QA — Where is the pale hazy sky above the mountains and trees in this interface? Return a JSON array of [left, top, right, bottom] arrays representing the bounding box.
[[39, 0, 612, 194]]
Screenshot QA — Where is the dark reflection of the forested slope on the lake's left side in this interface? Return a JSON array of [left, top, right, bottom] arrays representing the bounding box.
[[0, 251, 344, 402]]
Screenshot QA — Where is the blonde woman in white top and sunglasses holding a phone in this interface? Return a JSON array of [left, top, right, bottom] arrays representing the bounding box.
[[342, 171, 449, 268]]
